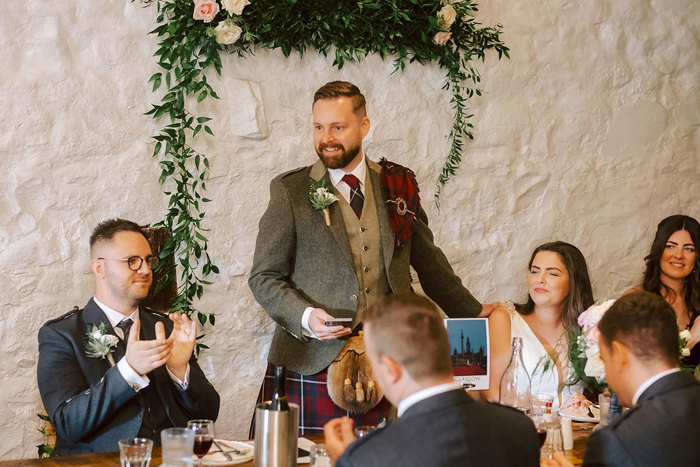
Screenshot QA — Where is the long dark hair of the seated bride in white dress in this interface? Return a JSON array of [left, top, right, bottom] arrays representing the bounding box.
[[515, 241, 593, 331]]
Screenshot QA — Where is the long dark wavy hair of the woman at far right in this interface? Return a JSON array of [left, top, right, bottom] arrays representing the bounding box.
[[642, 214, 700, 324]]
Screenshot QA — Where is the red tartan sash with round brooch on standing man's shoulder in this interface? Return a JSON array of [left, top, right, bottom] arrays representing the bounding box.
[[379, 158, 420, 248]]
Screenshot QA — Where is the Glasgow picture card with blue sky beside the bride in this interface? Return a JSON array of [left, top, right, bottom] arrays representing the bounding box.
[[445, 318, 490, 391]]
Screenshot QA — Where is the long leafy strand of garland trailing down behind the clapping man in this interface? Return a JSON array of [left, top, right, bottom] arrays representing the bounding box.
[[146, 1, 221, 332]]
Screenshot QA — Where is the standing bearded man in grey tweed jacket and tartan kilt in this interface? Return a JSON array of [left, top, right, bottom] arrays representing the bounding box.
[[248, 81, 490, 434]]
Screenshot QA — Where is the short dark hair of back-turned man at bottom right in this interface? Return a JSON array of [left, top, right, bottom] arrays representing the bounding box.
[[598, 292, 678, 366]]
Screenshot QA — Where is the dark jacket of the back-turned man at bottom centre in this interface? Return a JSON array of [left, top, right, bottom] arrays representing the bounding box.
[[336, 389, 540, 467]]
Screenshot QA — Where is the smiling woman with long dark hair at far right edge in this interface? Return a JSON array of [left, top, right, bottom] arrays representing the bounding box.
[[625, 215, 700, 367]]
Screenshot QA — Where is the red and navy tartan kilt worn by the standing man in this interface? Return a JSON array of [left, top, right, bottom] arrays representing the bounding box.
[[250, 363, 391, 439]]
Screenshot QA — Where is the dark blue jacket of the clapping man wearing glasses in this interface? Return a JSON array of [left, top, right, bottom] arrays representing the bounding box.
[[37, 299, 219, 456]]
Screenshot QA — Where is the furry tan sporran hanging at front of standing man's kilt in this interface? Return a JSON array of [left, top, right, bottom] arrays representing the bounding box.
[[326, 331, 384, 413]]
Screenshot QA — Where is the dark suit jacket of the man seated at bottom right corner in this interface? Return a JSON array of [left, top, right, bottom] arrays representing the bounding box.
[[583, 372, 700, 467]]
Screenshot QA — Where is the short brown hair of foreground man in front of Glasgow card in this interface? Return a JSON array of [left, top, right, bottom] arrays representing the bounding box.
[[363, 293, 452, 381]]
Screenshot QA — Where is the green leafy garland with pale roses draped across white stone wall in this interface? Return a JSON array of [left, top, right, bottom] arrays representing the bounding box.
[[142, 0, 508, 324]]
